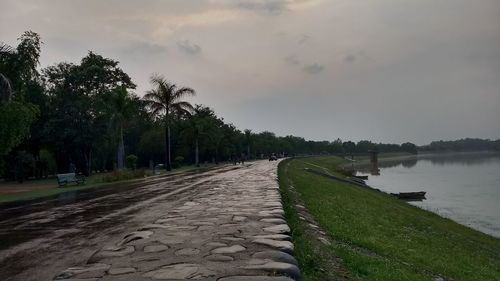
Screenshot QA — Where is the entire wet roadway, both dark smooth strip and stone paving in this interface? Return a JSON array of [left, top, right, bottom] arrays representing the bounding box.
[[0, 161, 300, 281]]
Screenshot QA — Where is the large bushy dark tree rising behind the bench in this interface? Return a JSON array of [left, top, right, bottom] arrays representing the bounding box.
[[43, 52, 135, 174]]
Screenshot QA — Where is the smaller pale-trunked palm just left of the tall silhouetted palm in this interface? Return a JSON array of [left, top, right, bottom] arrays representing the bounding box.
[[110, 86, 134, 169]]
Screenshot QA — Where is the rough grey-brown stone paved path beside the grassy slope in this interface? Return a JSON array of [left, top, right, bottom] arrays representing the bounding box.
[[54, 161, 300, 281]]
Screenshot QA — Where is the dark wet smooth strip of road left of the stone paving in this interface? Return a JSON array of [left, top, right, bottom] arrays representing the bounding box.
[[0, 166, 238, 250]]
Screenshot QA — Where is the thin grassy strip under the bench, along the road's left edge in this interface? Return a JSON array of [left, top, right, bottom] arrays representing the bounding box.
[[0, 165, 219, 203]]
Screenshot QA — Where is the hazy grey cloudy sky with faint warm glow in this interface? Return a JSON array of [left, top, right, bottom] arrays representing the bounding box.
[[0, 0, 500, 145]]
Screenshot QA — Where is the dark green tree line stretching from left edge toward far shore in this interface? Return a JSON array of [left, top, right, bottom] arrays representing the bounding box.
[[0, 31, 417, 179]]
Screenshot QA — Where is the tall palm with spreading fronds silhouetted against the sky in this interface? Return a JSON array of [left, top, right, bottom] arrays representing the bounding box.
[[144, 74, 195, 171]]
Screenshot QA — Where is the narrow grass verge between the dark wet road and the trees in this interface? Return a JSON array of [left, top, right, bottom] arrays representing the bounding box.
[[0, 165, 223, 204]]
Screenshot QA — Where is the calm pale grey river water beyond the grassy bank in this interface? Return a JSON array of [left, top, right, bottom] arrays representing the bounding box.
[[357, 153, 500, 237]]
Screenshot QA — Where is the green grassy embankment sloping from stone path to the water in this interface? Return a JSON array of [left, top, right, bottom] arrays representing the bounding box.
[[279, 157, 500, 281]]
